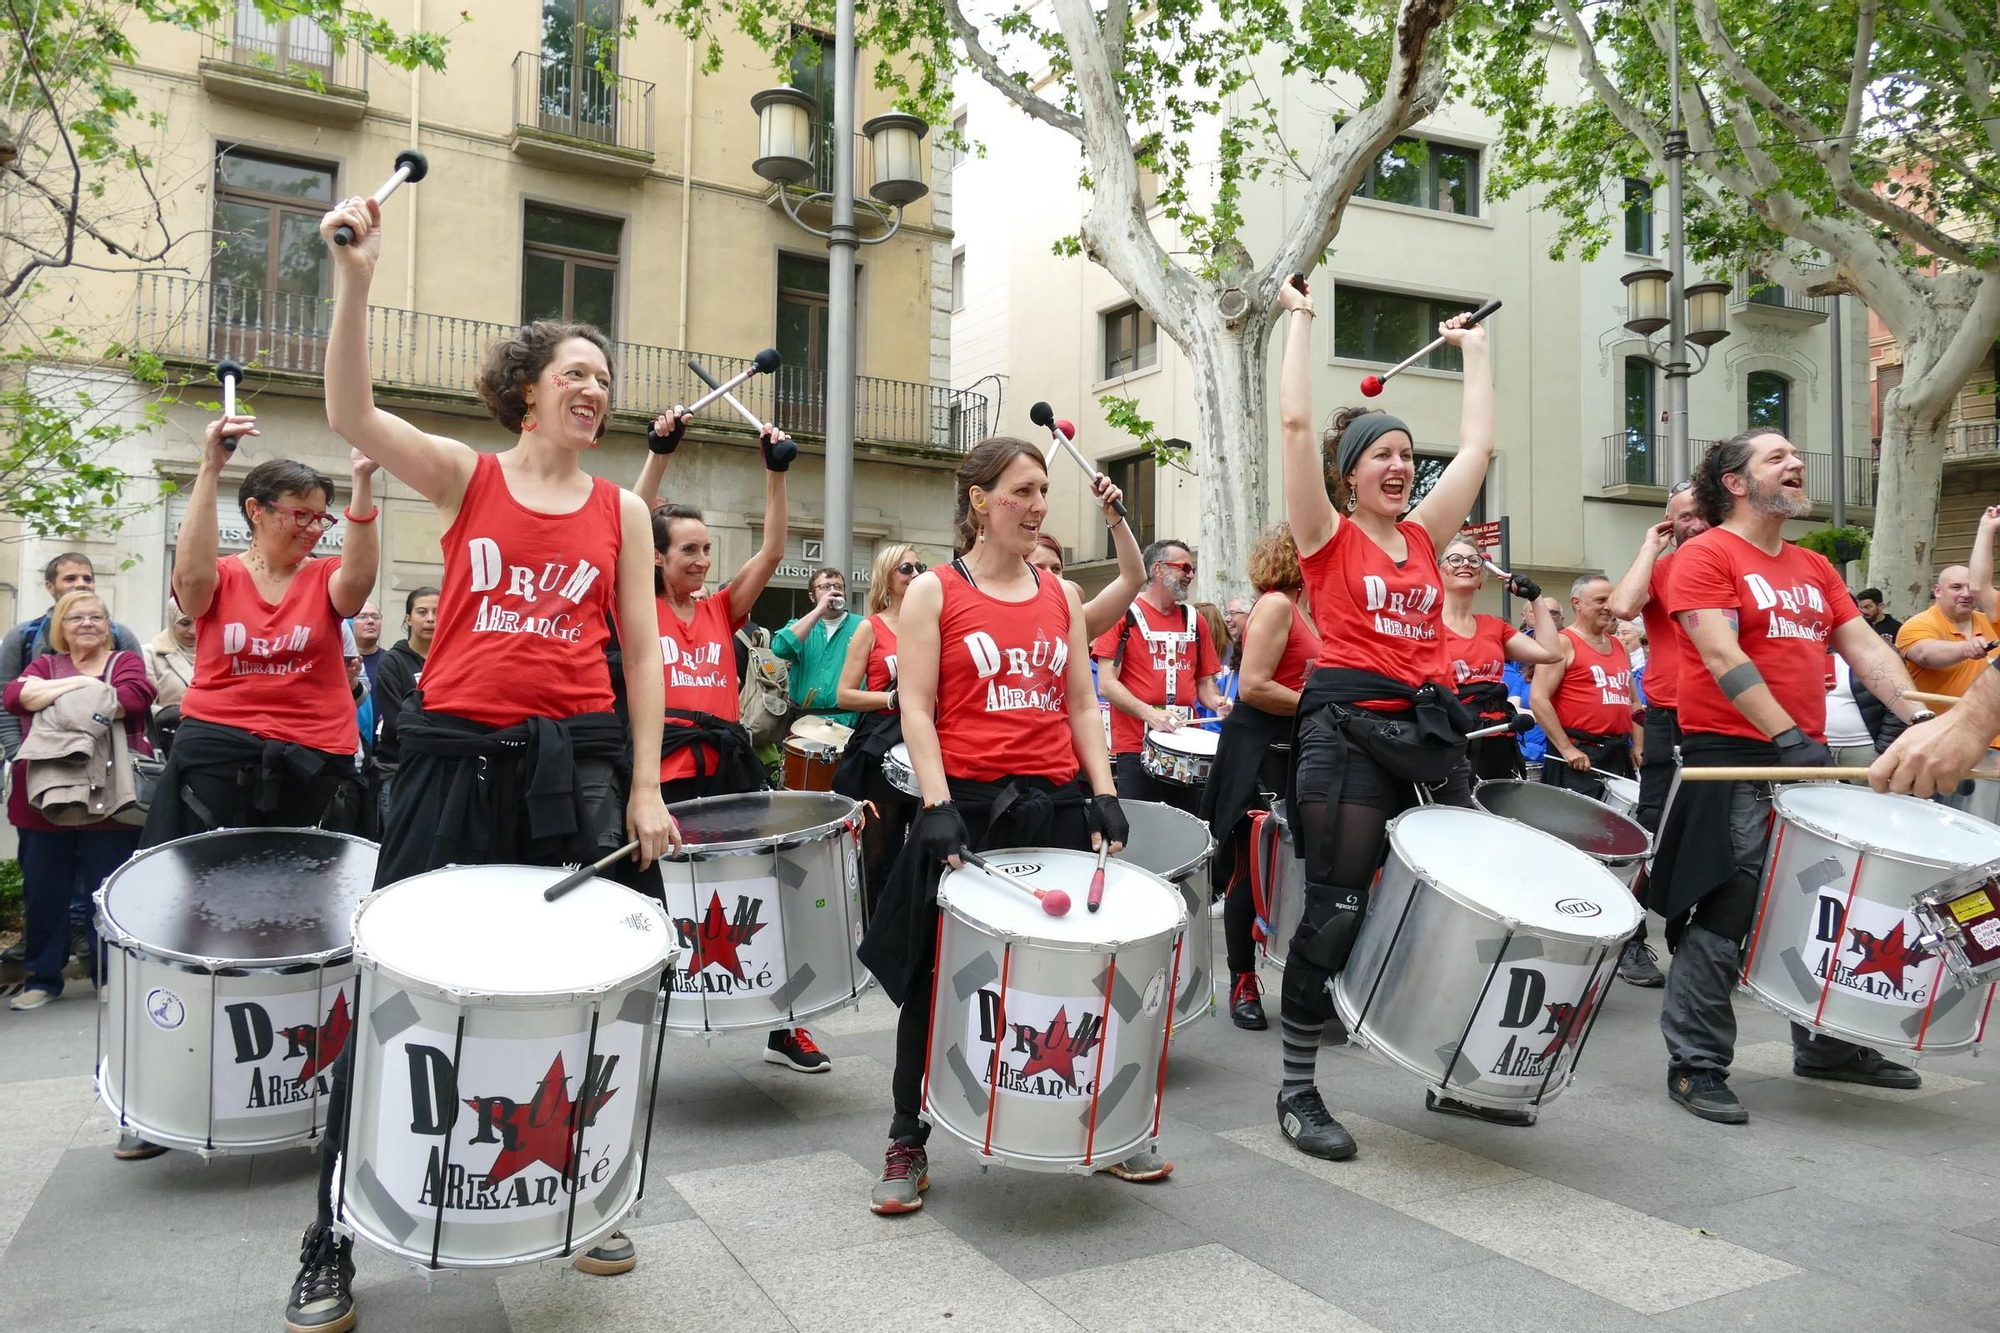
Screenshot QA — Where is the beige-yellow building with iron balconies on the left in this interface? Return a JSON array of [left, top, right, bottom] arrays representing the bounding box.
[[0, 0, 968, 638]]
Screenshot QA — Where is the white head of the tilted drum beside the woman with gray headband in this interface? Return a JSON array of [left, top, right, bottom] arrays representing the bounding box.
[[1388, 805, 1640, 943]]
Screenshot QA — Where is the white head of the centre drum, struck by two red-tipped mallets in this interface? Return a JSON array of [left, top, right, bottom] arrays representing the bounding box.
[[938, 847, 1188, 949]]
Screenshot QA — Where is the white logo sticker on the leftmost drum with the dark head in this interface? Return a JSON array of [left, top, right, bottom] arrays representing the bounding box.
[[221, 987, 354, 1117]]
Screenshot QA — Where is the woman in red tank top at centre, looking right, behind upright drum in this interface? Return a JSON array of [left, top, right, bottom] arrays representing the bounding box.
[[860, 438, 1174, 1213]]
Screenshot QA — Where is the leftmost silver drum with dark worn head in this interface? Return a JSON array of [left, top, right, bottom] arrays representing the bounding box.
[[96, 829, 376, 1155]]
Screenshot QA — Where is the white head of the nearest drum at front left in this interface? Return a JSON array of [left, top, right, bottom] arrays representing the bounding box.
[[354, 865, 674, 995]]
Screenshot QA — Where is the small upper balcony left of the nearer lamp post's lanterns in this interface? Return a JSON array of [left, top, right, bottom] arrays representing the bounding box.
[[508, 50, 654, 176]]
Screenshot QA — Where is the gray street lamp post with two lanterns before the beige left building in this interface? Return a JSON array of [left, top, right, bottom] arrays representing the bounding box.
[[750, 22, 930, 572]]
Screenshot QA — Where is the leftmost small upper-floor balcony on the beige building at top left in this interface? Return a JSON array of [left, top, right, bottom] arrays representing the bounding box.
[[200, 13, 368, 124]]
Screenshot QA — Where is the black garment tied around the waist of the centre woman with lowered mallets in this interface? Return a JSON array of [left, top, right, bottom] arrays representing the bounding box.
[[856, 777, 1090, 1005]]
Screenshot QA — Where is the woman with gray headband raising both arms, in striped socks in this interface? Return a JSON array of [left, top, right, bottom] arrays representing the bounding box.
[[1278, 278, 1504, 1161]]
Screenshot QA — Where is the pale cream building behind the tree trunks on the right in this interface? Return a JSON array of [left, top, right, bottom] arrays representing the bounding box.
[[952, 48, 1874, 608]]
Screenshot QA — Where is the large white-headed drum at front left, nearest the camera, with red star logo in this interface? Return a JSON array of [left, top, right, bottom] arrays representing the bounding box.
[[334, 865, 674, 1269]]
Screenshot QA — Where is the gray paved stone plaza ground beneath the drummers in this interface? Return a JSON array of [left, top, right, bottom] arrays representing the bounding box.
[[0, 940, 2000, 1333]]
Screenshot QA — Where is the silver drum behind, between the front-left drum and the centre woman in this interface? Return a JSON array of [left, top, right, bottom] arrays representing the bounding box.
[[660, 791, 874, 1037]]
